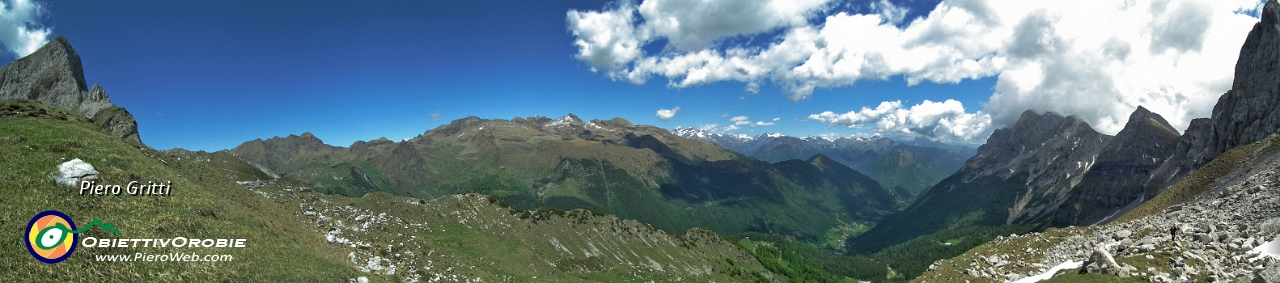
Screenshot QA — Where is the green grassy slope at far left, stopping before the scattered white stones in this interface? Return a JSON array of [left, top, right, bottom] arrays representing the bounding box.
[[0, 101, 361, 282]]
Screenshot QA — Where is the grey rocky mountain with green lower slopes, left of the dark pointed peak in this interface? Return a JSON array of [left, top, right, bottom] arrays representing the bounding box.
[[854, 110, 1112, 252]]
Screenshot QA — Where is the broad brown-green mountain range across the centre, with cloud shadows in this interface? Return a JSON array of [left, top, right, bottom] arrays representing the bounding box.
[[230, 114, 909, 242]]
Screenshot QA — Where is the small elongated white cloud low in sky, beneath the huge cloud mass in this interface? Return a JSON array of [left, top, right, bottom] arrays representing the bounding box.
[[808, 100, 992, 143]]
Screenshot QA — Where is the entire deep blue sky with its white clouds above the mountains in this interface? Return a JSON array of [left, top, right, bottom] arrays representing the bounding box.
[[0, 0, 1257, 150]]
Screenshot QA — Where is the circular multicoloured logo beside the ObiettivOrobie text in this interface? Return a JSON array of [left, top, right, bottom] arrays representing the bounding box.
[[27, 210, 79, 264]]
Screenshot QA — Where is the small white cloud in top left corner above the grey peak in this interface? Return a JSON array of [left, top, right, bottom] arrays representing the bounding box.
[[0, 0, 52, 58]]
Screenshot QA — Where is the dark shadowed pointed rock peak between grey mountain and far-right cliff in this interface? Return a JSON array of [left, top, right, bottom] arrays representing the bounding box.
[[1053, 106, 1179, 225]]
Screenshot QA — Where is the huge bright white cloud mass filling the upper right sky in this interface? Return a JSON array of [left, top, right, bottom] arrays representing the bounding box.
[[567, 0, 1258, 133]]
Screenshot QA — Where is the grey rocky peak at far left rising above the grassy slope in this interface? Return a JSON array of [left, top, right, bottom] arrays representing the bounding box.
[[0, 36, 142, 145]]
